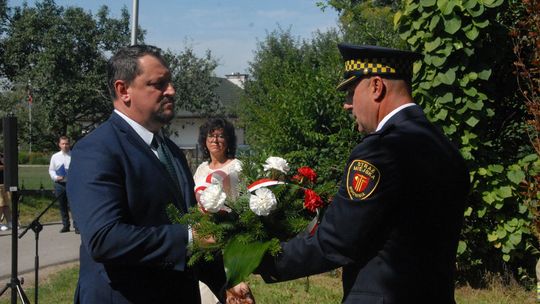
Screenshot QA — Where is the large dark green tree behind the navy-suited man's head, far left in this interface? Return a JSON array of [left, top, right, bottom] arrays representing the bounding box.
[[1, 0, 135, 149]]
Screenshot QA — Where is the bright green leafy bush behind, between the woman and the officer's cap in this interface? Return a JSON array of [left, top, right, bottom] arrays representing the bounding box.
[[240, 30, 359, 186]]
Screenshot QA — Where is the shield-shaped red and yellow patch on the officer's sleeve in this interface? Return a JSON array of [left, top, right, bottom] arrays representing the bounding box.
[[347, 159, 381, 200]]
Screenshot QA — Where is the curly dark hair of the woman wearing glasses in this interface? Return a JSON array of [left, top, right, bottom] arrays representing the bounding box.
[[199, 118, 236, 160]]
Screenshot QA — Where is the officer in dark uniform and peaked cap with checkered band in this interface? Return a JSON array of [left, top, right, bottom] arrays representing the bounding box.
[[258, 44, 469, 304]]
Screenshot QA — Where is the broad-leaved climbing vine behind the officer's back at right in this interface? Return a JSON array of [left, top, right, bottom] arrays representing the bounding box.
[[395, 0, 540, 278]]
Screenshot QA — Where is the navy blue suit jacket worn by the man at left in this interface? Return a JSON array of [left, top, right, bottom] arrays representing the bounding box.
[[67, 113, 225, 304]]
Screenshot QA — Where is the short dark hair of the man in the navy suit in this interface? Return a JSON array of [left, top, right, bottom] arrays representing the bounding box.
[[107, 44, 166, 100]]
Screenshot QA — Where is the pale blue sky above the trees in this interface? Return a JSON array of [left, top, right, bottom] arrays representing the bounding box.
[[15, 0, 337, 76]]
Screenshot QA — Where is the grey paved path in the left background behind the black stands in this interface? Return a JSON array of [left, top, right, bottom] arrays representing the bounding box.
[[0, 223, 81, 282]]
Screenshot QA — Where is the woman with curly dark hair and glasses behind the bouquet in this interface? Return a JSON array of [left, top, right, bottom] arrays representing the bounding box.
[[193, 118, 242, 304]]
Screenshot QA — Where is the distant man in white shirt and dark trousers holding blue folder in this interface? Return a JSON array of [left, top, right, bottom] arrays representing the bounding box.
[[49, 136, 79, 234]]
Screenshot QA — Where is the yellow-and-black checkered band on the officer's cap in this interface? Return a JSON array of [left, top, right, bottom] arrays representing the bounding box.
[[345, 58, 412, 75]]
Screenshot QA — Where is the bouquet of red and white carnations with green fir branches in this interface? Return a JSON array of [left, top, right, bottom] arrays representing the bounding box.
[[168, 157, 325, 286]]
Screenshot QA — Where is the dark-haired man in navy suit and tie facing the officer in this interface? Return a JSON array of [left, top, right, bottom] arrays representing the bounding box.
[[67, 45, 251, 304]]
